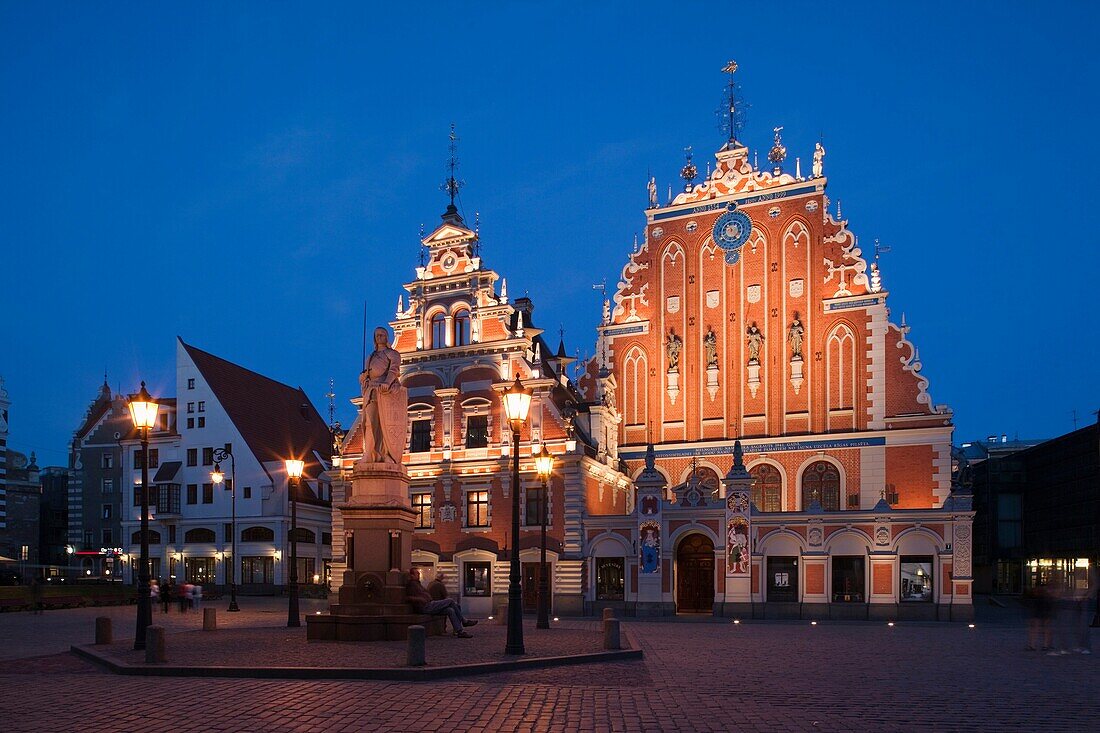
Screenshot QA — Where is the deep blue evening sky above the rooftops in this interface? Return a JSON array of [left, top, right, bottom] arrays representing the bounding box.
[[0, 2, 1100, 464]]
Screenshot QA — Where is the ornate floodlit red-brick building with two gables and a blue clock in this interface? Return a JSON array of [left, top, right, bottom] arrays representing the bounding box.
[[333, 67, 972, 619]]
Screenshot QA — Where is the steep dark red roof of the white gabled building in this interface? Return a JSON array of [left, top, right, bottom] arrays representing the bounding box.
[[179, 339, 332, 477]]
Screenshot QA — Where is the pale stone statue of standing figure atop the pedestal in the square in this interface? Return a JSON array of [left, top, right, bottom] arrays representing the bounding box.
[[359, 326, 408, 466]]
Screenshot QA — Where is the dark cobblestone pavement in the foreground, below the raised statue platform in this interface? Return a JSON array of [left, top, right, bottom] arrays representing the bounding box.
[[0, 616, 1100, 733]]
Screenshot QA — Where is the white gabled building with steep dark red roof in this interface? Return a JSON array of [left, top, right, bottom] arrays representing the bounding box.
[[120, 340, 332, 593]]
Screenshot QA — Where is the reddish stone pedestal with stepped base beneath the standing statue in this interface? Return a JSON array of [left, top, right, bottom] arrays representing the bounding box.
[[306, 461, 443, 642]]
